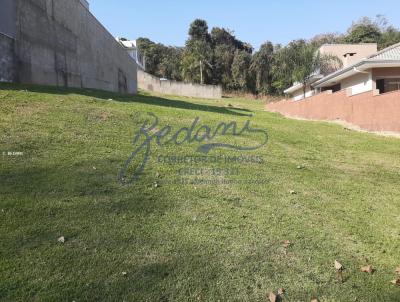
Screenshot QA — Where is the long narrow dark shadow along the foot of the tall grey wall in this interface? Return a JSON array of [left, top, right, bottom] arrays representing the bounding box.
[[0, 83, 252, 116]]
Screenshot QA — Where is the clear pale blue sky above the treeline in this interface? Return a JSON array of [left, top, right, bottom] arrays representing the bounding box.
[[89, 0, 400, 49]]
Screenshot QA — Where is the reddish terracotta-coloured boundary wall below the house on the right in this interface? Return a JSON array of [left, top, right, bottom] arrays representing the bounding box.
[[266, 91, 400, 133]]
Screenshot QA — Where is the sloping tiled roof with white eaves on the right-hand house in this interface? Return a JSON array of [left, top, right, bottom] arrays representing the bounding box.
[[313, 43, 400, 87]]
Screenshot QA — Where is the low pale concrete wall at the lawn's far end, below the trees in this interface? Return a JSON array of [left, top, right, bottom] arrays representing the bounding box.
[[138, 69, 222, 99]]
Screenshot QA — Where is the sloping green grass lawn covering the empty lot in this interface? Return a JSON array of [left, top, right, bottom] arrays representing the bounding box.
[[0, 84, 400, 302]]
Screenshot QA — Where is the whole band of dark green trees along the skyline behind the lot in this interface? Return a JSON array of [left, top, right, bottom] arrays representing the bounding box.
[[137, 16, 400, 94]]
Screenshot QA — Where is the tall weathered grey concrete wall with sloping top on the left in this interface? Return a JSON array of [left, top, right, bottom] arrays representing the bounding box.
[[0, 0, 137, 93]]
